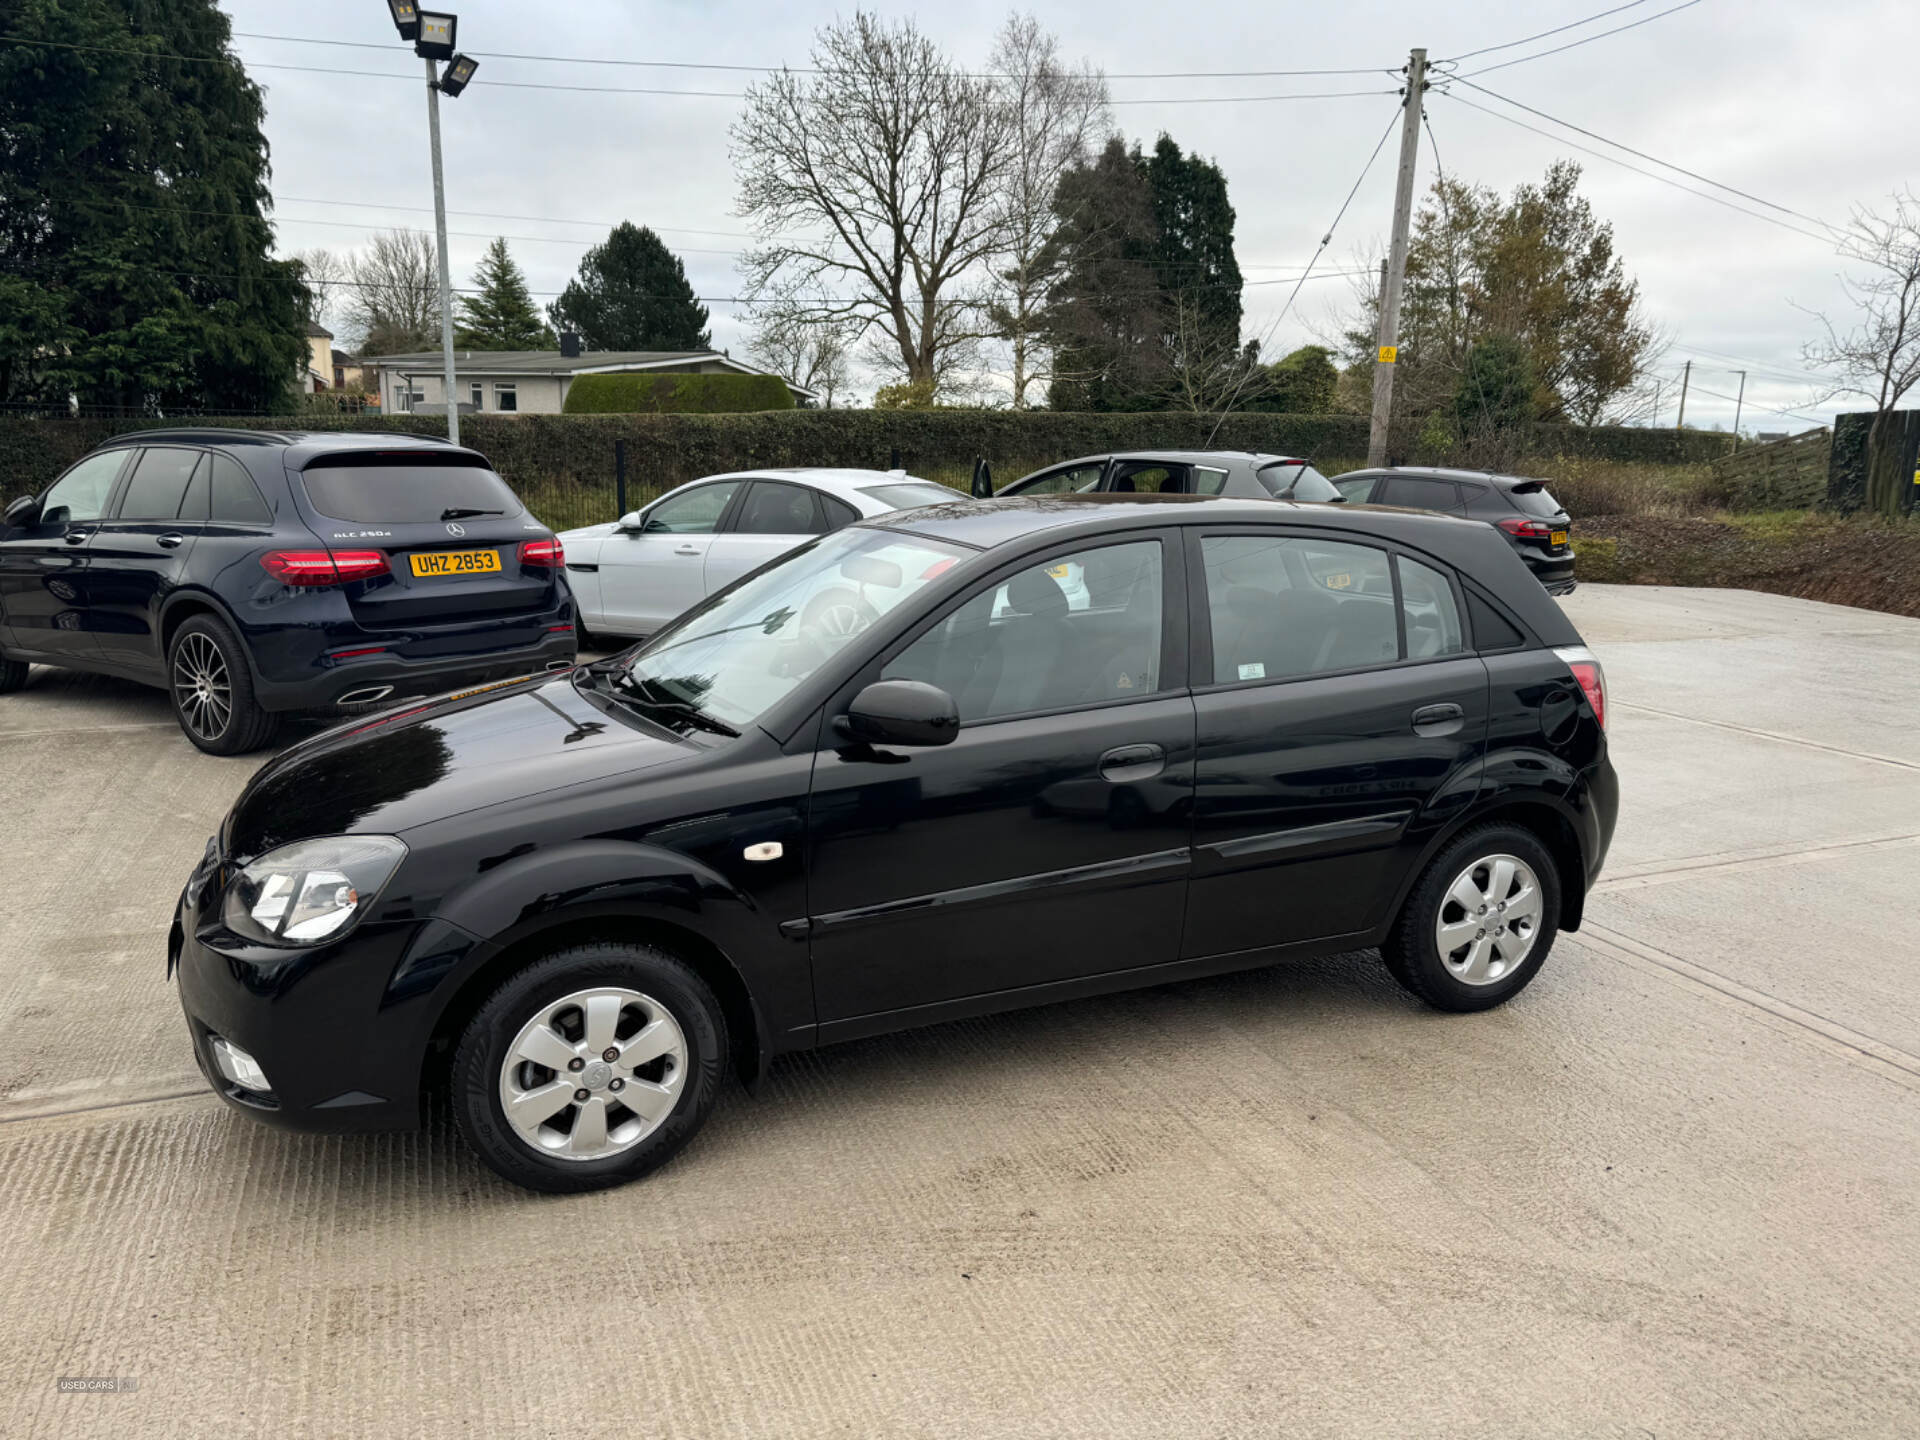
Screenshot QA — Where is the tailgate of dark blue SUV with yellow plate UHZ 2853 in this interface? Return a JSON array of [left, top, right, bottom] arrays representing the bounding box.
[[293, 449, 566, 630]]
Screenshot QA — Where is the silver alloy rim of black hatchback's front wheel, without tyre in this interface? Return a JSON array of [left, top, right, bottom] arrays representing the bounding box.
[[499, 985, 687, 1160]]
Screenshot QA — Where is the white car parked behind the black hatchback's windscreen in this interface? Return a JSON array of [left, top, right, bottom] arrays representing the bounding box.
[[561, 470, 966, 639]]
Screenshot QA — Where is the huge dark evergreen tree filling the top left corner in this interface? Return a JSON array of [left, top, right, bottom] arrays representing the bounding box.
[[0, 0, 305, 411]]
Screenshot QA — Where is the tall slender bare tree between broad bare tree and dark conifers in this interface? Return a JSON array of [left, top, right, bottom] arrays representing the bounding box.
[[987, 13, 1112, 411]]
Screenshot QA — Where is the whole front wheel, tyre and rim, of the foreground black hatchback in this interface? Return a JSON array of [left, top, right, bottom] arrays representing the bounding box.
[[453, 941, 728, 1194]]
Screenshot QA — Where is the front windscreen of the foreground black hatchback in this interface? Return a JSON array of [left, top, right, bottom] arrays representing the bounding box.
[[618, 526, 972, 730]]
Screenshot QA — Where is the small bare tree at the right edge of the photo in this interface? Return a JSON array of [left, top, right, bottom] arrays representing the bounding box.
[[1803, 190, 1920, 515]]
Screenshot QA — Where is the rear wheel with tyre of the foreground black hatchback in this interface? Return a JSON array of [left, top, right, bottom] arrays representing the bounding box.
[[1380, 824, 1561, 1012]]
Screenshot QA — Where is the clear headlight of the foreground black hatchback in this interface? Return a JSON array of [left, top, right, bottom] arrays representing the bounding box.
[[221, 835, 407, 945]]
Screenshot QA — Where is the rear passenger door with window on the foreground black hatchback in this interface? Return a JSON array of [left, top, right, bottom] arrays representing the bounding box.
[[1183, 532, 1488, 958]]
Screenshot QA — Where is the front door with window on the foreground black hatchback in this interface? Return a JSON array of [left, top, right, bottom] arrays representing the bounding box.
[[808, 536, 1194, 1039]]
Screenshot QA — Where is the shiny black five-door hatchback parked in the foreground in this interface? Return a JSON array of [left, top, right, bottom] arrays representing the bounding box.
[[169, 495, 1617, 1190]]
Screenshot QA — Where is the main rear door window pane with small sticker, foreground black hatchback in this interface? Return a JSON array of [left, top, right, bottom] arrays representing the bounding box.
[[1200, 536, 1400, 685]]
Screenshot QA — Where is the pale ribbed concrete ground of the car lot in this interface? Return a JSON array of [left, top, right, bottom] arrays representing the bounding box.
[[0, 588, 1920, 1440]]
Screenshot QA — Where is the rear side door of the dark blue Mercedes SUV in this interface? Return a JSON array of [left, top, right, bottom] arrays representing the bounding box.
[[88, 445, 211, 674]]
